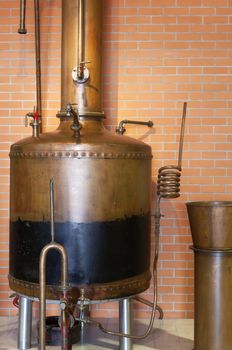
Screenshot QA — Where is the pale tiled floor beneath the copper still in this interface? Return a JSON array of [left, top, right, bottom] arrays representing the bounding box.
[[0, 317, 193, 350]]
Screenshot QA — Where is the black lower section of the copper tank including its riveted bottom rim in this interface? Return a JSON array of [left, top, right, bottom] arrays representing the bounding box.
[[10, 213, 150, 299]]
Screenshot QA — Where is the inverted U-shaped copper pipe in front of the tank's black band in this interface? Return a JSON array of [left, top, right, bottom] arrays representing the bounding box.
[[39, 242, 68, 350]]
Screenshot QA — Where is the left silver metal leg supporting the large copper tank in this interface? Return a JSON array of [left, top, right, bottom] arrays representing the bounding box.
[[18, 296, 32, 350]]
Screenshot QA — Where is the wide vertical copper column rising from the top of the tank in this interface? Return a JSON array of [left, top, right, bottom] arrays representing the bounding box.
[[61, 0, 103, 117]]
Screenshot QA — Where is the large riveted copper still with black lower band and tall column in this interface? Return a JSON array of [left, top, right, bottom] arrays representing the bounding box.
[[9, 0, 152, 300]]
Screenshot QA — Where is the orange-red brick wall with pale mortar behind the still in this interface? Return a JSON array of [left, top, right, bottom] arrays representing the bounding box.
[[0, 0, 232, 318]]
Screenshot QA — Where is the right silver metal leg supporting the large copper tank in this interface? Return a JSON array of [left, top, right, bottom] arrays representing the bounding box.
[[119, 298, 133, 350]]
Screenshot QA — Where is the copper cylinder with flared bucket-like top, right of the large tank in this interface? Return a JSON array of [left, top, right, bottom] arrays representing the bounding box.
[[187, 202, 232, 350]]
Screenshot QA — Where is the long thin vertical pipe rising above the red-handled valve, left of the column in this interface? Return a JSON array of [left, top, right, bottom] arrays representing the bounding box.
[[34, 0, 42, 132]]
